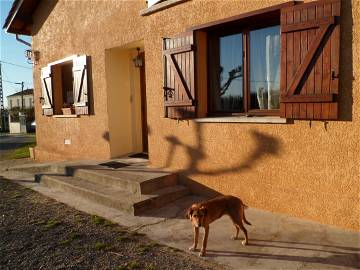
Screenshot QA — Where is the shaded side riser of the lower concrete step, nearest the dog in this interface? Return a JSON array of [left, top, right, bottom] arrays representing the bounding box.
[[134, 189, 190, 215]]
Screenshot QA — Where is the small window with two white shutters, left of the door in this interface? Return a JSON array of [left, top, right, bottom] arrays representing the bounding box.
[[41, 55, 89, 115]]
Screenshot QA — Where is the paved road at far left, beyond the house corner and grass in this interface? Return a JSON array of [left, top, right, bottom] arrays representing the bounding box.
[[0, 133, 35, 159]]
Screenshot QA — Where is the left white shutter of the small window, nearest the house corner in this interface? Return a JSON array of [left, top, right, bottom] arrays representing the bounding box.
[[41, 66, 54, 115]]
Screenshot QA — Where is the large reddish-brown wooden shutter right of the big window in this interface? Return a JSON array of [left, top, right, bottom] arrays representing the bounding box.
[[280, 0, 340, 120]]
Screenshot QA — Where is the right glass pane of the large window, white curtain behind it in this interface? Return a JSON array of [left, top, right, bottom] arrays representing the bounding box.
[[250, 26, 280, 110]]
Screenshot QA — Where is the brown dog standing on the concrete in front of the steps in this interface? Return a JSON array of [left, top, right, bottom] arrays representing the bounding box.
[[186, 196, 251, 256]]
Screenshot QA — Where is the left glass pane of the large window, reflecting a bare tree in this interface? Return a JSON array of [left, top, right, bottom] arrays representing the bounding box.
[[211, 33, 243, 112]]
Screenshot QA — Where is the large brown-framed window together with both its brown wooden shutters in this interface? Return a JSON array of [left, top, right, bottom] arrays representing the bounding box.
[[163, 0, 341, 120]]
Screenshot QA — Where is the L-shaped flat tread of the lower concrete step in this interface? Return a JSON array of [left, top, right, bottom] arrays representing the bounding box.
[[41, 175, 188, 204]]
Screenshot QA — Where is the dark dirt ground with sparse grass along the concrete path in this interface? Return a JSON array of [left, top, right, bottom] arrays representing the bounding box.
[[0, 177, 224, 270]]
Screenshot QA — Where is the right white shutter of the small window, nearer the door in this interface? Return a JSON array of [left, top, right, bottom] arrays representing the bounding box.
[[73, 55, 89, 114]]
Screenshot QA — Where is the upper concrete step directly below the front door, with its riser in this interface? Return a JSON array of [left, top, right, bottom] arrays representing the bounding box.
[[66, 166, 177, 194]]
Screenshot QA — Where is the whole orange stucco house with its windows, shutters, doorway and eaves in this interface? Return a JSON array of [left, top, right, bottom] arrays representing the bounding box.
[[4, 0, 360, 231]]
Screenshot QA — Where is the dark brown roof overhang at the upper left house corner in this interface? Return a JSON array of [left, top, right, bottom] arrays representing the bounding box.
[[3, 0, 40, 36]]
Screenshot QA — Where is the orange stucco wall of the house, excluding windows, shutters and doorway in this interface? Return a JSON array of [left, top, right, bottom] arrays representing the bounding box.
[[32, 0, 360, 231]]
